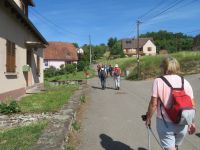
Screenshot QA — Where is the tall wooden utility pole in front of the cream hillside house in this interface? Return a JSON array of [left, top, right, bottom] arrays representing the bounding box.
[[137, 20, 142, 80]]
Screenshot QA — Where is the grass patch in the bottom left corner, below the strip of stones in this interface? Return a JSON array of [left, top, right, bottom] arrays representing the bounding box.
[[0, 121, 48, 150]]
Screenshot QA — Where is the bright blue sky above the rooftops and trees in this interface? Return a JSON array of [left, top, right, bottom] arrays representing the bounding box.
[[29, 0, 200, 46]]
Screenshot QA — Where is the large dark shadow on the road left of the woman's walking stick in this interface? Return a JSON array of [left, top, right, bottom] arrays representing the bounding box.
[[99, 134, 134, 150]]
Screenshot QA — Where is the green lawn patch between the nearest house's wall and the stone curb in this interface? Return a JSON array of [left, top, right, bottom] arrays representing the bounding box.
[[19, 85, 78, 113]]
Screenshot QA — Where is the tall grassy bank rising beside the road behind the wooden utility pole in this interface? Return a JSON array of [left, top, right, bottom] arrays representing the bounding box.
[[98, 51, 200, 80]]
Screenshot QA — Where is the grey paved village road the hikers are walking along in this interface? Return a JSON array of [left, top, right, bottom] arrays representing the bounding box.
[[79, 74, 200, 150]]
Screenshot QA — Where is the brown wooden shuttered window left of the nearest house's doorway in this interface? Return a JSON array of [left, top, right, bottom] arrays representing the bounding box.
[[6, 40, 16, 73]]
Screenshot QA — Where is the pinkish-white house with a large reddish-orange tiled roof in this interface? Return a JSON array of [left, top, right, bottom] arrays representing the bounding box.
[[44, 42, 78, 68]]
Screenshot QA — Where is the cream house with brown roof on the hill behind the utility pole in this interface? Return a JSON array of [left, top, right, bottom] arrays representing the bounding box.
[[122, 38, 156, 56]]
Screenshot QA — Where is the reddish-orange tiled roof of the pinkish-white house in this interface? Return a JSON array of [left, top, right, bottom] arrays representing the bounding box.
[[44, 42, 78, 61]]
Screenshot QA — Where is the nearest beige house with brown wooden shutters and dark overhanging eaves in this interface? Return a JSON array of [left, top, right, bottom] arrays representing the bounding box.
[[0, 0, 48, 100]]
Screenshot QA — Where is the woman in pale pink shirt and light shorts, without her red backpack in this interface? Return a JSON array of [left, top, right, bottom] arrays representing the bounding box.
[[146, 56, 195, 150]]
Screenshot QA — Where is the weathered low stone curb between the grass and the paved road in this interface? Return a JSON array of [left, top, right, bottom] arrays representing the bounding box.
[[31, 84, 88, 150]]
